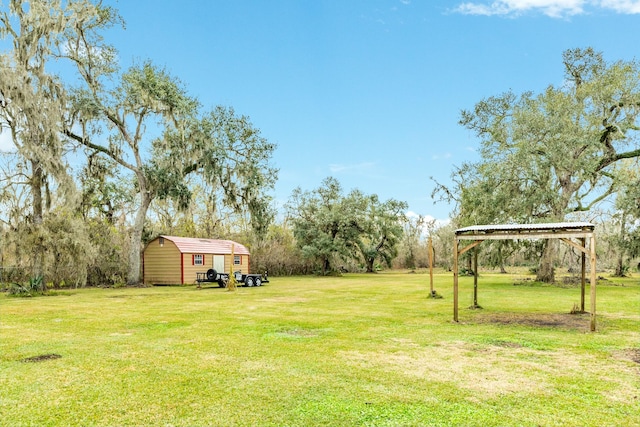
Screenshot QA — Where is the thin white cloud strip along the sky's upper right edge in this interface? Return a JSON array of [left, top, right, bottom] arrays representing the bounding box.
[[453, 0, 640, 18]]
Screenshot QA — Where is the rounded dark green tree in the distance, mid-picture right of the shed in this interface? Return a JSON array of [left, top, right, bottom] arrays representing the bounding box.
[[288, 178, 407, 274]]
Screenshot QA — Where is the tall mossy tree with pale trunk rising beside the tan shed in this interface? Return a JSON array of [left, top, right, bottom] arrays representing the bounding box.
[[66, 60, 276, 284]]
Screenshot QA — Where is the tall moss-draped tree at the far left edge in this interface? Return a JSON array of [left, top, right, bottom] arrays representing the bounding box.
[[0, 0, 112, 290]]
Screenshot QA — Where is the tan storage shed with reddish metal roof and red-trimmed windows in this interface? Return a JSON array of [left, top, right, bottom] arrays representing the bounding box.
[[142, 236, 250, 285]]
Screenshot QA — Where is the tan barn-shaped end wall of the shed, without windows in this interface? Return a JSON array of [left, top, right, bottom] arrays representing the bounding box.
[[143, 239, 183, 285]]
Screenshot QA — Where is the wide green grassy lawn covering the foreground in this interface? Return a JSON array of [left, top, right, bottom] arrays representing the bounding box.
[[0, 272, 640, 426]]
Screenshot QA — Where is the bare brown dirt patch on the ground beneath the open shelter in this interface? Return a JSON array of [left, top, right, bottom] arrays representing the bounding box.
[[474, 313, 590, 329]]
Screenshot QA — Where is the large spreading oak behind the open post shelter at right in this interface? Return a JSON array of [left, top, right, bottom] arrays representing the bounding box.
[[435, 48, 640, 282]]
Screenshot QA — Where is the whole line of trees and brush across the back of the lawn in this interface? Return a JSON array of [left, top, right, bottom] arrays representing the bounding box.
[[0, 0, 640, 286]]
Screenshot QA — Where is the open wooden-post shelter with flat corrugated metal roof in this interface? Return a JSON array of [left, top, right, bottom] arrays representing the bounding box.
[[453, 222, 596, 331]]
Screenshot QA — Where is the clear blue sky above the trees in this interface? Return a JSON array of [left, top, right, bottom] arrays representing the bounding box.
[[3, 0, 640, 219]]
